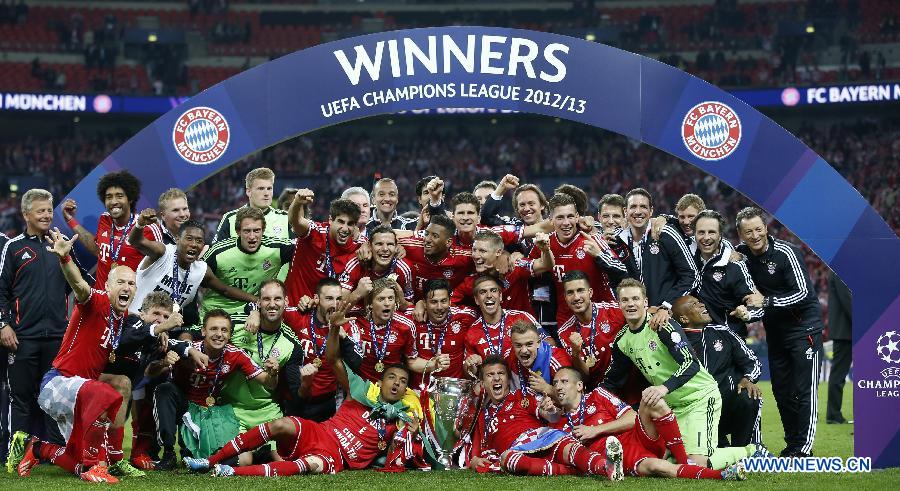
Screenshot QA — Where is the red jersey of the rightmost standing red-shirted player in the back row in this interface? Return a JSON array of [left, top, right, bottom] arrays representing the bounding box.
[[531, 232, 625, 326]]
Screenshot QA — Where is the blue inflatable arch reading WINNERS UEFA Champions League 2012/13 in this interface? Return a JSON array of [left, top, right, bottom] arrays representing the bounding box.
[[56, 27, 900, 467]]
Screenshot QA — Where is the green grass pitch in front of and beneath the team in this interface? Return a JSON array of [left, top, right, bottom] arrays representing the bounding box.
[[0, 383, 900, 491]]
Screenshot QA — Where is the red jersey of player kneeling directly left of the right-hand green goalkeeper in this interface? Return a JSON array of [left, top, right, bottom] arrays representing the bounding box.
[[559, 302, 625, 387]]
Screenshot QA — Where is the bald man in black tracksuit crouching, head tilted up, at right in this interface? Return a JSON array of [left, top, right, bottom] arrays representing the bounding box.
[[672, 295, 762, 447]]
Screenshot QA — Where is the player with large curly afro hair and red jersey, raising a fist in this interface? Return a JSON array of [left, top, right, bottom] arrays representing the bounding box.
[[62, 171, 144, 288]]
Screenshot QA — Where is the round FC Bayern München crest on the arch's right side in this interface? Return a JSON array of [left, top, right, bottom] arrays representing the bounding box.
[[681, 101, 741, 161]]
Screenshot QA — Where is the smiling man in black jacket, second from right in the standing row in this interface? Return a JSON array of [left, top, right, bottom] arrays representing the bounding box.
[[691, 210, 763, 339]]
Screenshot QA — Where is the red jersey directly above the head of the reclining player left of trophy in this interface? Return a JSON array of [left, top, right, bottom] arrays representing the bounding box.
[[343, 313, 418, 382]]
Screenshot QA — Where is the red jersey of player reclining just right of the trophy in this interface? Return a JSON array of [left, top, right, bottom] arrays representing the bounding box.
[[472, 391, 547, 456]]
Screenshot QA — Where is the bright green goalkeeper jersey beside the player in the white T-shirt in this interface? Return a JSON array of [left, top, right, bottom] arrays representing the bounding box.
[[200, 236, 294, 319]]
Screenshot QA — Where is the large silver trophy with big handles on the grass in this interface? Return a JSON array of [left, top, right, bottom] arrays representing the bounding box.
[[430, 377, 478, 469]]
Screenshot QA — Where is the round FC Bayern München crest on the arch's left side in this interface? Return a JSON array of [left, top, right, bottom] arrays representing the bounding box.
[[172, 107, 231, 165]]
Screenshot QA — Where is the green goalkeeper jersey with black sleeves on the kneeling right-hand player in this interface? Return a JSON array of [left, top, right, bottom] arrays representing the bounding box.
[[603, 317, 719, 409]]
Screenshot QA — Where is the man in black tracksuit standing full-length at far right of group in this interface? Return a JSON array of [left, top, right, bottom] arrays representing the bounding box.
[[735, 207, 823, 457]]
